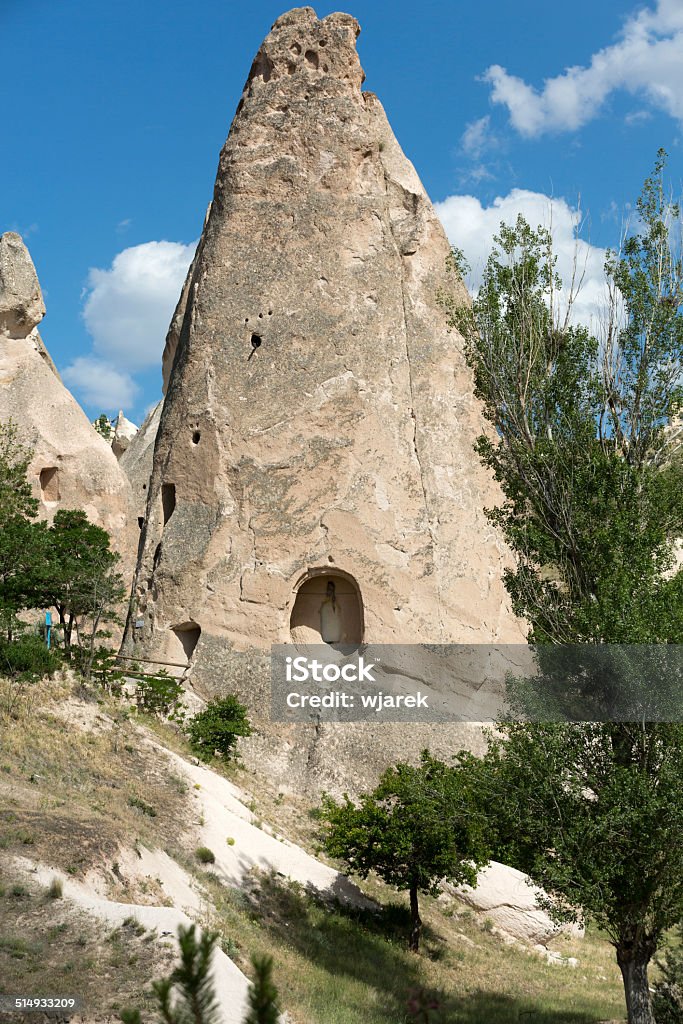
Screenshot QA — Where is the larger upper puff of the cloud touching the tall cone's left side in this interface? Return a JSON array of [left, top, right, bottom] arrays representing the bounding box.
[[83, 242, 196, 373]]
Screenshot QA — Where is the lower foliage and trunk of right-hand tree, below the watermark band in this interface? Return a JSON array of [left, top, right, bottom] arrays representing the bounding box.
[[486, 722, 683, 1024]]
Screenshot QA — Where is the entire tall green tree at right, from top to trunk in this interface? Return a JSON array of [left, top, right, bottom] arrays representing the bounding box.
[[444, 153, 683, 1024]]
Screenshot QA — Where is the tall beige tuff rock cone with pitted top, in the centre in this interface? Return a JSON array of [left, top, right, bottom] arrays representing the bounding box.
[[122, 7, 523, 785]]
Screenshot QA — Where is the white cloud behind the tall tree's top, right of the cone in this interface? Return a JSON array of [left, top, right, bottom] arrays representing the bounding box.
[[436, 188, 606, 331]]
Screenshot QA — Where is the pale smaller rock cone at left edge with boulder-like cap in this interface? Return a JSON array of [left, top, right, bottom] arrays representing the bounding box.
[[0, 231, 136, 570]]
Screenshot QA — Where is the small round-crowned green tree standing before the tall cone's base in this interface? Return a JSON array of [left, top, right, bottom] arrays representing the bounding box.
[[322, 752, 489, 952]]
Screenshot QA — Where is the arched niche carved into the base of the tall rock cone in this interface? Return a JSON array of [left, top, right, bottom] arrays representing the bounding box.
[[290, 568, 364, 644]]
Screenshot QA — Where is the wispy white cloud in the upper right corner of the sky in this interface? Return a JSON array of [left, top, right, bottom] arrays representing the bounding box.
[[483, 0, 683, 137]]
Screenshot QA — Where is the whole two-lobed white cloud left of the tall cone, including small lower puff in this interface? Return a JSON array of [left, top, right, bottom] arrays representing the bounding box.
[[63, 242, 196, 411]]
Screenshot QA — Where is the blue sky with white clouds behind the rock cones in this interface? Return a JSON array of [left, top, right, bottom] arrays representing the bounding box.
[[0, 0, 683, 422]]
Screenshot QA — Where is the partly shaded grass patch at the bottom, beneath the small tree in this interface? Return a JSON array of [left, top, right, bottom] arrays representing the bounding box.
[[189, 872, 624, 1024]]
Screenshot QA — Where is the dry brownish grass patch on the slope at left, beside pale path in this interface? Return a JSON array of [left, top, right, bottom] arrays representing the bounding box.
[[0, 683, 189, 876]]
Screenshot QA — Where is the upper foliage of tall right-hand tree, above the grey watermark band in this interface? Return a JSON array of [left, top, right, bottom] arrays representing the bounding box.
[[450, 156, 683, 643]]
